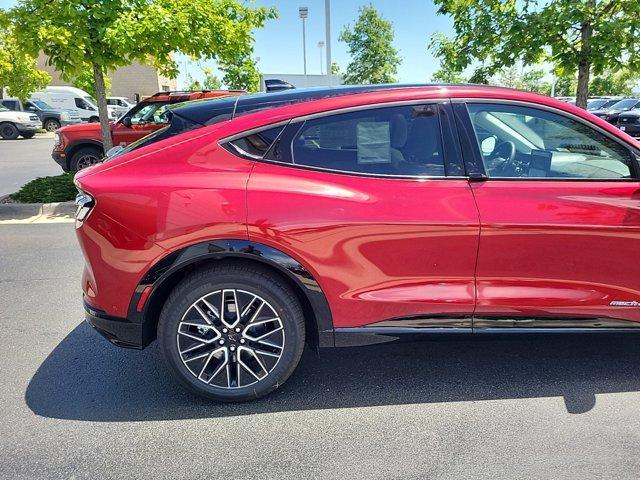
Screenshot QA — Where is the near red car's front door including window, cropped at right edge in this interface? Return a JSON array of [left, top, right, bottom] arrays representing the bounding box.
[[454, 101, 640, 329]]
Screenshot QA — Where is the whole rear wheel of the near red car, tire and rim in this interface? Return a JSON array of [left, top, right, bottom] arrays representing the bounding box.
[[158, 264, 305, 402]]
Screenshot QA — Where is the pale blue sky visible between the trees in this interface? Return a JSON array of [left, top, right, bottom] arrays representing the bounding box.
[[0, 0, 451, 86]]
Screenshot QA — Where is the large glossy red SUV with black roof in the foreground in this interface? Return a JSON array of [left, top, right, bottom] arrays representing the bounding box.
[[76, 86, 640, 401]]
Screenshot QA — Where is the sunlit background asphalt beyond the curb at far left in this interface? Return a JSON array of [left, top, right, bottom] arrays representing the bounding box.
[[0, 134, 62, 197]]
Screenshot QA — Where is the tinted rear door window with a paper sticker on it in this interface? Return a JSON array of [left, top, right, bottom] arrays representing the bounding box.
[[293, 105, 445, 177]]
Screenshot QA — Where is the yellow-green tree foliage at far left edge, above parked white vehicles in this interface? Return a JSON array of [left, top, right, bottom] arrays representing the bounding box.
[[0, 10, 51, 101]]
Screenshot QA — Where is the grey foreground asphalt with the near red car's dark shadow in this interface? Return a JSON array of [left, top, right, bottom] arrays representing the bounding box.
[[0, 224, 640, 479]]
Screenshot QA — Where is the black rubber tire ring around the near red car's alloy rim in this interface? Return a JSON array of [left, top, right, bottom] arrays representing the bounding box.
[[158, 269, 305, 402]]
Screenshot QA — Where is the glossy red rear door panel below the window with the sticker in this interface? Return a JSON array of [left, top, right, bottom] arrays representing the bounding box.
[[247, 164, 479, 327]]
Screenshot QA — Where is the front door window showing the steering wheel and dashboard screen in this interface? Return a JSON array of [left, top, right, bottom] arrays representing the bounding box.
[[468, 103, 633, 180]]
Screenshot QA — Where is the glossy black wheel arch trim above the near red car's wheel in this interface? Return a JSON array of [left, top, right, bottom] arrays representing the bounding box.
[[127, 239, 334, 348]]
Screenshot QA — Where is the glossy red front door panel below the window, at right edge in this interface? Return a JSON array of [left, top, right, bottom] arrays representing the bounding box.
[[472, 181, 640, 321]]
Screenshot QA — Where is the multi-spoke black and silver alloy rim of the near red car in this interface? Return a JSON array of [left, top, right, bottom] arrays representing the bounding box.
[[176, 288, 285, 389]]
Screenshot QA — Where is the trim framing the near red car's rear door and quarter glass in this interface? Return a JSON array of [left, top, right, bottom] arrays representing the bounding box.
[[218, 97, 468, 181]]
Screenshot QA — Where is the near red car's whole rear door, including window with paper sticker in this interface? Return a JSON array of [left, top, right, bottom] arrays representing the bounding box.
[[241, 103, 479, 334]]
